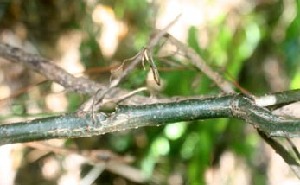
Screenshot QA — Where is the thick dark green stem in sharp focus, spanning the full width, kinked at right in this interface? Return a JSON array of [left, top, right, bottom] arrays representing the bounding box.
[[0, 94, 300, 144]]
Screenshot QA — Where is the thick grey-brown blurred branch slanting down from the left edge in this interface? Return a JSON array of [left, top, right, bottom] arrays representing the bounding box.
[[0, 43, 151, 105]]
